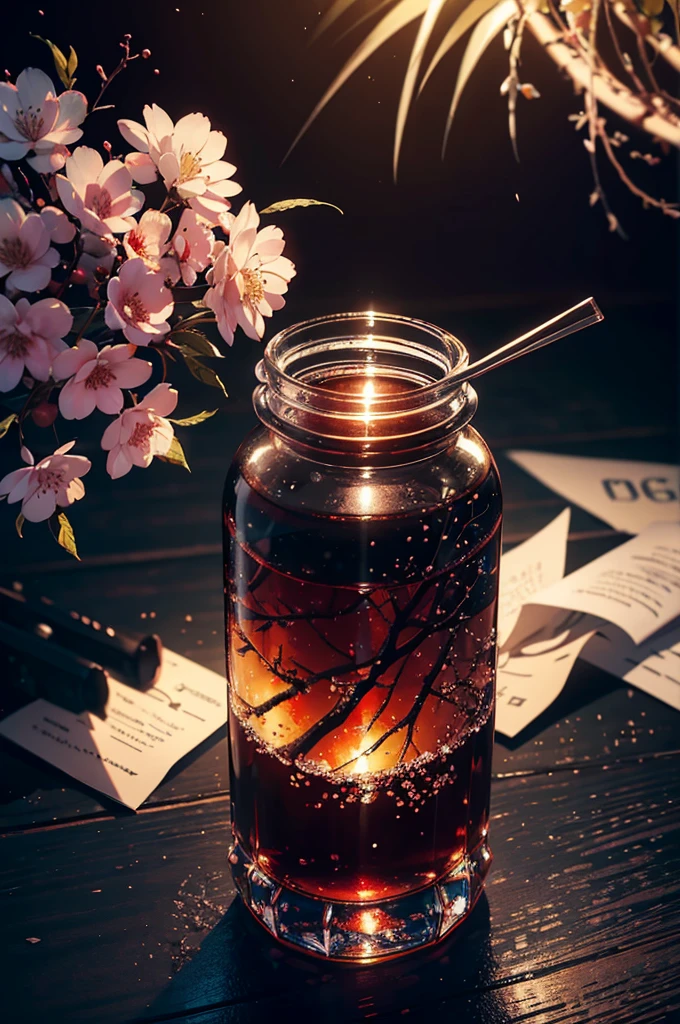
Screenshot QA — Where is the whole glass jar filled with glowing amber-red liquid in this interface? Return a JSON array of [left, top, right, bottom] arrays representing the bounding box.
[[224, 313, 501, 961]]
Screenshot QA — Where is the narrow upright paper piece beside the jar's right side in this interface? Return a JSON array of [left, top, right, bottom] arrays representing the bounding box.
[[498, 509, 571, 646]]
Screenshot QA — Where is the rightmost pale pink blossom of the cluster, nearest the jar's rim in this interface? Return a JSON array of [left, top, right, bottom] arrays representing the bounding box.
[[204, 203, 295, 345]]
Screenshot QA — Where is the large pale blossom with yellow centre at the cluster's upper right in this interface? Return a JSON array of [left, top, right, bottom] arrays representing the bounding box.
[[118, 104, 241, 208]]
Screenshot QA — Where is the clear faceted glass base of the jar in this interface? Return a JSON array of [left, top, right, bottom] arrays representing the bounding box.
[[228, 842, 492, 964]]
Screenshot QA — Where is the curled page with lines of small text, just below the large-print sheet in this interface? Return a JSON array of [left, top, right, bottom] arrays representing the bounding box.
[[533, 522, 680, 644]]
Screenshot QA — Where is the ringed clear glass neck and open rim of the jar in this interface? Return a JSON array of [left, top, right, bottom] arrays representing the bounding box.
[[253, 312, 476, 464]]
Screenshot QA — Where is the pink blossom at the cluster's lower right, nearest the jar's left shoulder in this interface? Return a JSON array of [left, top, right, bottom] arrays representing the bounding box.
[[101, 384, 177, 480]]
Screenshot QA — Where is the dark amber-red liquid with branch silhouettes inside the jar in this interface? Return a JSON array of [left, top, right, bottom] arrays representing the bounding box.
[[225, 378, 500, 901]]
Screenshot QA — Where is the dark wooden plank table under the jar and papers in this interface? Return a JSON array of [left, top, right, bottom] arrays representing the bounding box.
[[0, 302, 680, 1024]]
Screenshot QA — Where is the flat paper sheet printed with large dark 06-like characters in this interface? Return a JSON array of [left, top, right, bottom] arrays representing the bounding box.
[[507, 452, 680, 534]]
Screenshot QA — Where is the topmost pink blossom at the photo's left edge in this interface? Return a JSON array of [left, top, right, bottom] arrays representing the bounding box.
[[0, 68, 87, 174]]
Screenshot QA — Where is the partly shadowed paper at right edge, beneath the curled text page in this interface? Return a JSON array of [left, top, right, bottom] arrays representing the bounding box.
[[581, 622, 680, 711]]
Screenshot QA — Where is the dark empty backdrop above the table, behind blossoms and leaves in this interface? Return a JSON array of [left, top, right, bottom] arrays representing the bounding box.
[[0, 0, 677, 315]]
